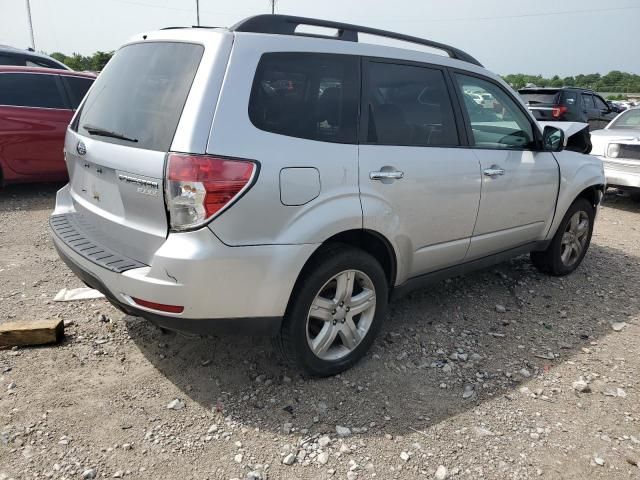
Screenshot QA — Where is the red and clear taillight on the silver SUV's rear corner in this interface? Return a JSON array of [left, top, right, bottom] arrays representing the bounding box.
[[165, 153, 257, 230]]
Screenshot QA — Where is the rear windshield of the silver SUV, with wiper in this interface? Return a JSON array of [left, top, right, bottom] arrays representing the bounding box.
[[76, 42, 204, 152]]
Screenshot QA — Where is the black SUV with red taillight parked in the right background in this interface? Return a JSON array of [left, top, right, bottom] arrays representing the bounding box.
[[518, 87, 617, 130]]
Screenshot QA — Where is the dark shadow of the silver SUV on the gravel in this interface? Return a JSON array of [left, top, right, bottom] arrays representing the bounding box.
[[125, 245, 640, 435]]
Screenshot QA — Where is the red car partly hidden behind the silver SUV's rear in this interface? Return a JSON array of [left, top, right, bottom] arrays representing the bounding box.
[[0, 66, 96, 185]]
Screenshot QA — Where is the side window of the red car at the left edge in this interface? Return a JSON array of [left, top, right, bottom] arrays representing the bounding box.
[[0, 73, 67, 108]]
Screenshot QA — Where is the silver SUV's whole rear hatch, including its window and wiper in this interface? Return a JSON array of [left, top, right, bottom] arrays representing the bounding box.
[[65, 37, 208, 264]]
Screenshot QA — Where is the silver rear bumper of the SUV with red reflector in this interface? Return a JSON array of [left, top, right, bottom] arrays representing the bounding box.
[[51, 187, 317, 334]]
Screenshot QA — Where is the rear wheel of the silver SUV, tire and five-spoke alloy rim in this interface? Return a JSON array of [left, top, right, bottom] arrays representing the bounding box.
[[274, 244, 389, 377]]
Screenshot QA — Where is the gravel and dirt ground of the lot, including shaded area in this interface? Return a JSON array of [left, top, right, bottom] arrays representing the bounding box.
[[0, 185, 640, 480]]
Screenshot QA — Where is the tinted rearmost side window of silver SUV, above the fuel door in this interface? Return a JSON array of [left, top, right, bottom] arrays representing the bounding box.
[[249, 53, 360, 143]]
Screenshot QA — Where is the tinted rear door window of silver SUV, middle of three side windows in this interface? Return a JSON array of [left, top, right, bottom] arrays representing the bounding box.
[[365, 62, 459, 146]]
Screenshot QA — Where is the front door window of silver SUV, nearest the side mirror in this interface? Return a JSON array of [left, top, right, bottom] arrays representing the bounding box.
[[455, 74, 535, 150]]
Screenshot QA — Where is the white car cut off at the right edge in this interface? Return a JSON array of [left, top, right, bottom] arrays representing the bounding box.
[[591, 107, 640, 198]]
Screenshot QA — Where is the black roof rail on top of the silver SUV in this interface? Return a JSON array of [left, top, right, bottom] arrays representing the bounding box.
[[231, 15, 482, 67]]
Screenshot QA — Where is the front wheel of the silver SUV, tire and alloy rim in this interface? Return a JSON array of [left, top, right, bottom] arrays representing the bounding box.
[[531, 197, 595, 276]]
